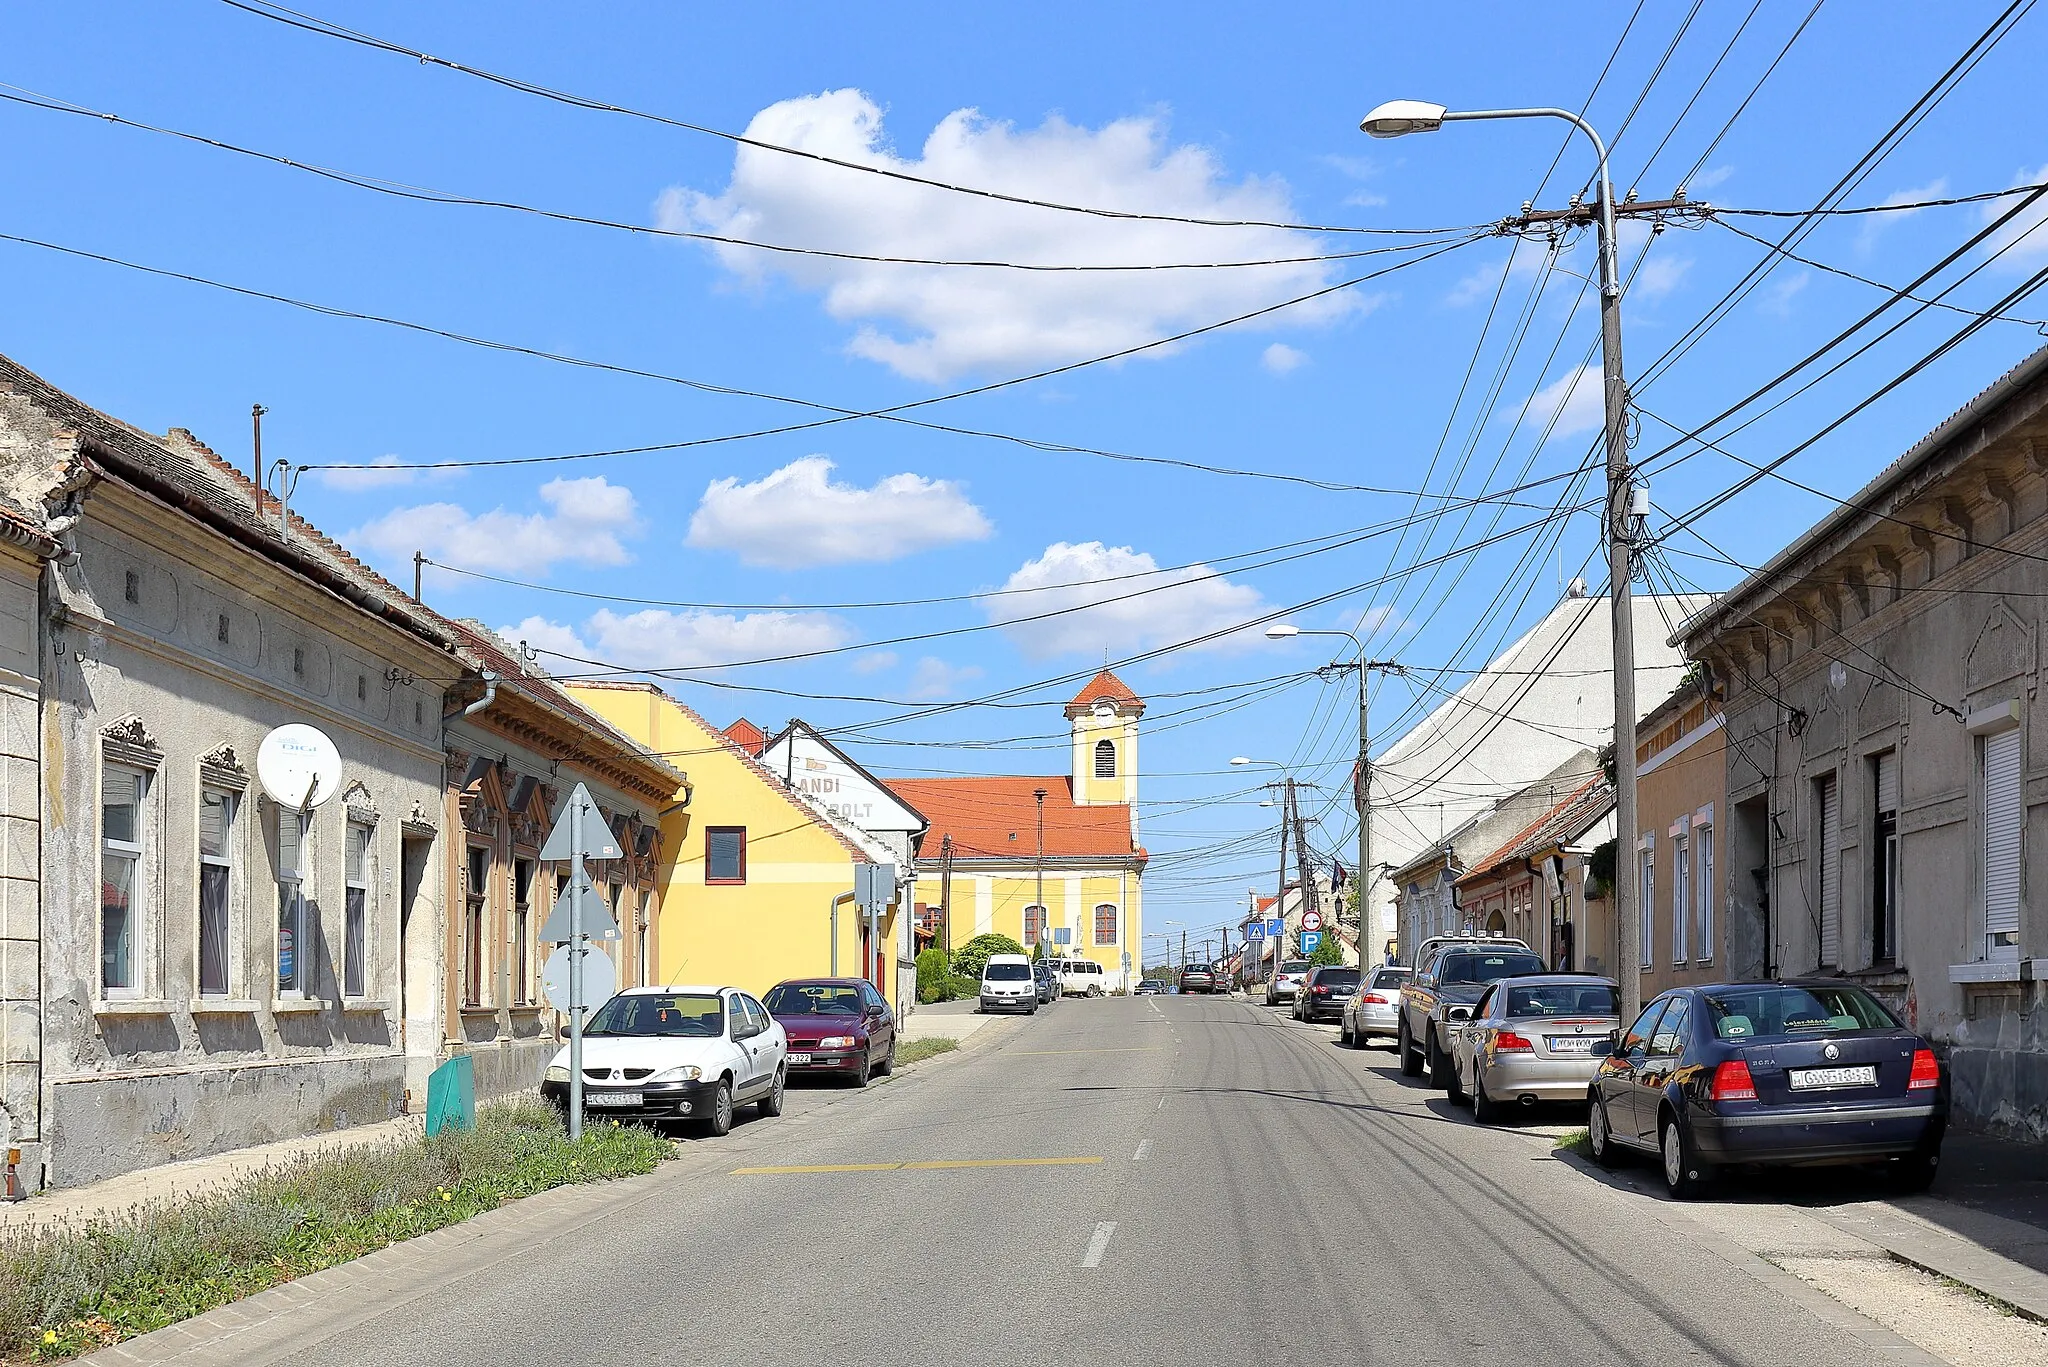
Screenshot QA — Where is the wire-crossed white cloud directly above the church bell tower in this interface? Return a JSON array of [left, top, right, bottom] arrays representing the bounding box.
[[981, 541, 1266, 660]]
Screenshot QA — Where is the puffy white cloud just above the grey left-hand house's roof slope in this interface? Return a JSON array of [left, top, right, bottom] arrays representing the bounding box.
[[342, 475, 639, 574]]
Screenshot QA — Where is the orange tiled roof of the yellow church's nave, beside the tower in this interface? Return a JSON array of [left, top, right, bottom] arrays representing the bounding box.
[[889, 775, 1145, 861]]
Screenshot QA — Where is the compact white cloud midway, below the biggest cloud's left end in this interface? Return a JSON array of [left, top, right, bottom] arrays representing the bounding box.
[[688, 455, 993, 570]]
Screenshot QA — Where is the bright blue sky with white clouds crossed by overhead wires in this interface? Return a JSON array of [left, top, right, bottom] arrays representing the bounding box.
[[0, 0, 2048, 950]]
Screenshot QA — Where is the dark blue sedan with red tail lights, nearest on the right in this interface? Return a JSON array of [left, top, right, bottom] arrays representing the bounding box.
[[1587, 982, 1948, 1199]]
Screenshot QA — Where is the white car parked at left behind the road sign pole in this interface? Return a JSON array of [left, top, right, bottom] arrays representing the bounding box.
[[541, 988, 788, 1135]]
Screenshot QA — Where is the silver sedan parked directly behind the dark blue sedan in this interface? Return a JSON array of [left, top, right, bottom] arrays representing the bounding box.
[[1450, 974, 1620, 1125]]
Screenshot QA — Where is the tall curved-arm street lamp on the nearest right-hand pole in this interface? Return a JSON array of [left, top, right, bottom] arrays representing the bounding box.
[[1358, 100, 1642, 1021]]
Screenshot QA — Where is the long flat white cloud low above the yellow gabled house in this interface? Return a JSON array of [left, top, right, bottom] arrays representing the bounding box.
[[498, 609, 852, 670]]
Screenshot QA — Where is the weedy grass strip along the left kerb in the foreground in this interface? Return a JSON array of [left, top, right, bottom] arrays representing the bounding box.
[[0, 1103, 674, 1363]]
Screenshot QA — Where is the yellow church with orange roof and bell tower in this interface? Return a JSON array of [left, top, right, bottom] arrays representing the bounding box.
[[889, 670, 1147, 992]]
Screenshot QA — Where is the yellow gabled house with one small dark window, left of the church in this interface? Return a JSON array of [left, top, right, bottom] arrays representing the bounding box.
[[569, 682, 899, 1000]]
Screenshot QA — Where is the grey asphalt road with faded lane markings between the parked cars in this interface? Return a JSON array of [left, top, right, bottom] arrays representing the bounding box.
[[123, 996, 1929, 1367]]
